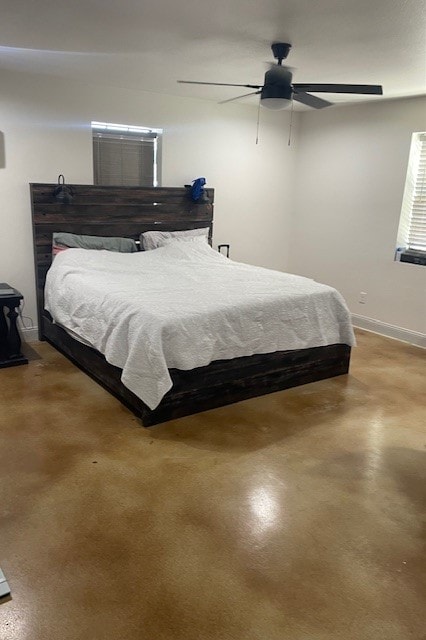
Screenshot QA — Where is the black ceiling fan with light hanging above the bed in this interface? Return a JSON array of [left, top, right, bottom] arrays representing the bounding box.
[[178, 42, 383, 109]]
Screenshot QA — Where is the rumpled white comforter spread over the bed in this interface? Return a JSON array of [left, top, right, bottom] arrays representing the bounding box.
[[45, 242, 354, 409]]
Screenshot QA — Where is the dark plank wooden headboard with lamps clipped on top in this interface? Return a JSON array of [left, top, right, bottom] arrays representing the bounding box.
[[30, 183, 214, 337]]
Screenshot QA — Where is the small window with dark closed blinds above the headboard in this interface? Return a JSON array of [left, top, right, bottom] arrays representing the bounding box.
[[92, 122, 162, 187]]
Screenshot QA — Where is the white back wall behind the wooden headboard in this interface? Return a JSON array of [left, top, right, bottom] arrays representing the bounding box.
[[0, 73, 297, 330]]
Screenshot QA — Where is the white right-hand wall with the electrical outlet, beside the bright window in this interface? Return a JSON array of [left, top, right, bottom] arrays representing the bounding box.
[[289, 98, 426, 333]]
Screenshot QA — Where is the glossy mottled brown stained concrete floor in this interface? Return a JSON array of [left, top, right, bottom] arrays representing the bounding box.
[[0, 332, 426, 640]]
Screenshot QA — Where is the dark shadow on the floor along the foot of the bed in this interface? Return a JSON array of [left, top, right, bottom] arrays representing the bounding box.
[[149, 376, 368, 453]]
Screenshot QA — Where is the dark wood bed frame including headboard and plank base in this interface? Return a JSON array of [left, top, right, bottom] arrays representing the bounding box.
[[30, 184, 351, 426]]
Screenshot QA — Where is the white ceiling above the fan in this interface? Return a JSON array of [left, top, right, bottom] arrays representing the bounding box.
[[0, 0, 426, 106]]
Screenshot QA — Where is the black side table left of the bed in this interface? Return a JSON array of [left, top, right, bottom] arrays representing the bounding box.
[[0, 282, 28, 368]]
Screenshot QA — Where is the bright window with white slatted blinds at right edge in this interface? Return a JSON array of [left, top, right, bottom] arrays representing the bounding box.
[[397, 132, 426, 264]]
